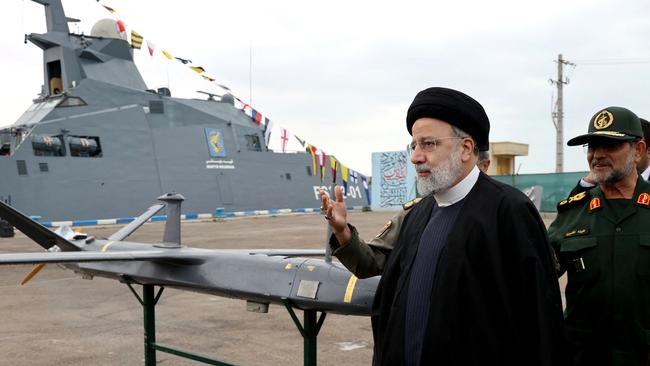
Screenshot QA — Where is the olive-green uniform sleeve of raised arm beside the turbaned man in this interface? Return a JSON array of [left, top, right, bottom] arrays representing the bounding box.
[[330, 198, 421, 278]]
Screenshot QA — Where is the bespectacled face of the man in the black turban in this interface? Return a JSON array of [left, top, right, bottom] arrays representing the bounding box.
[[411, 118, 463, 196]]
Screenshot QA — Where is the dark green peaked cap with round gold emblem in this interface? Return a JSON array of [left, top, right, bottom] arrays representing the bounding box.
[[567, 107, 643, 146]]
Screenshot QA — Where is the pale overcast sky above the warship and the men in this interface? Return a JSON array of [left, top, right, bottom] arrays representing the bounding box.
[[0, 0, 650, 174]]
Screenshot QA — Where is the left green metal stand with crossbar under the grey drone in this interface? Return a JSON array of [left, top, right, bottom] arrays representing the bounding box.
[[126, 282, 232, 366]]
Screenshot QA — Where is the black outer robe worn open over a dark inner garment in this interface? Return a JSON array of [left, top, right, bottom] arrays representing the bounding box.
[[372, 174, 564, 366]]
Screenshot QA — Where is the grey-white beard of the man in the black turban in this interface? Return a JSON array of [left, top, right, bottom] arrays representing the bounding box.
[[415, 146, 463, 196]]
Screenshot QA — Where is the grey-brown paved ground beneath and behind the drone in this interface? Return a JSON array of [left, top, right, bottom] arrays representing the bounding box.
[[0, 212, 552, 366]]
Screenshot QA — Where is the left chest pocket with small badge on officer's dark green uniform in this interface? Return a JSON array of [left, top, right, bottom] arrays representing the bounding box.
[[560, 237, 596, 283]]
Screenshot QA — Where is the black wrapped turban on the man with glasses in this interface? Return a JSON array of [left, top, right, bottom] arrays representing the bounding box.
[[406, 87, 490, 151]]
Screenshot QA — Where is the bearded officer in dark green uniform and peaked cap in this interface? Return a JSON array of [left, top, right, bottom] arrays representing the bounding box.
[[549, 107, 650, 366]]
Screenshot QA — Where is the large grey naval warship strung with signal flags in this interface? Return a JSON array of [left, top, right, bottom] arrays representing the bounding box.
[[0, 0, 368, 220]]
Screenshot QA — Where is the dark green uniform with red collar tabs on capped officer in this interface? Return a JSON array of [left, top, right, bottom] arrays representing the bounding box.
[[549, 177, 650, 365]]
